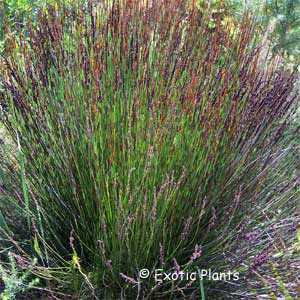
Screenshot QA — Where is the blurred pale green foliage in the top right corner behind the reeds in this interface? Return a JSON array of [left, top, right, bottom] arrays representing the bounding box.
[[197, 0, 300, 66]]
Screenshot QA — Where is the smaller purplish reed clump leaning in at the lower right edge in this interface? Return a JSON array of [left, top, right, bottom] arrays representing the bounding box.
[[218, 135, 300, 299]]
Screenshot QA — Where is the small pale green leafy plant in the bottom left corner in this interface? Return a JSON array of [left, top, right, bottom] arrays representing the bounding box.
[[0, 252, 39, 300]]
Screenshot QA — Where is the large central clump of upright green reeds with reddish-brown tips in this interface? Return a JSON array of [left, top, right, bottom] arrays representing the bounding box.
[[0, 0, 295, 299]]
